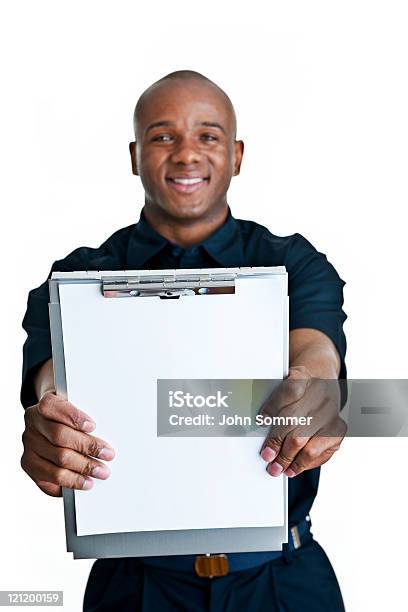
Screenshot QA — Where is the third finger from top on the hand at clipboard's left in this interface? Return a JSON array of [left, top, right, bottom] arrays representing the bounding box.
[[24, 431, 110, 480]]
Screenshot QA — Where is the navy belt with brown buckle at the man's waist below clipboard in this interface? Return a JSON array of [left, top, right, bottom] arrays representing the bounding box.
[[141, 516, 311, 578]]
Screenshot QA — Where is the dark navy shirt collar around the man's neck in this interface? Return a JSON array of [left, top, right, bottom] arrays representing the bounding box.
[[127, 207, 243, 270]]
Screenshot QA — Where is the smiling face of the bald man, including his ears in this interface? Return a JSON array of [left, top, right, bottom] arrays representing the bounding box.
[[131, 80, 243, 220]]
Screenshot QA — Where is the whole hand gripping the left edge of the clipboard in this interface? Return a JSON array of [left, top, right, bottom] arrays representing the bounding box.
[[21, 392, 115, 497]]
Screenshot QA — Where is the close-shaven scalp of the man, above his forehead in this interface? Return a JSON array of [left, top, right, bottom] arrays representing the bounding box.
[[133, 70, 237, 139]]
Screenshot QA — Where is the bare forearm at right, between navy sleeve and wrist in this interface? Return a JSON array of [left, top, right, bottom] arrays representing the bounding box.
[[289, 329, 340, 379]]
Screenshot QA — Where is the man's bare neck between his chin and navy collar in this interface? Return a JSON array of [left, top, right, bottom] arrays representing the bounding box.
[[143, 204, 228, 248]]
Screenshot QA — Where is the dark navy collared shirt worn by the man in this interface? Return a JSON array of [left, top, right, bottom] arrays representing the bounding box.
[[21, 209, 346, 527]]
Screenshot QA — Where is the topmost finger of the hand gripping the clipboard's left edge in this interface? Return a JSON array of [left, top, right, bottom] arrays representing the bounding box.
[[37, 393, 96, 433]]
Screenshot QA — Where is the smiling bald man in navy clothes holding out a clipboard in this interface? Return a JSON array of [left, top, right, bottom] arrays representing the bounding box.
[[21, 71, 346, 612]]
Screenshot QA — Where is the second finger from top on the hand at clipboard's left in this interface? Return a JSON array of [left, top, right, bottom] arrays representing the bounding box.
[[30, 417, 115, 461]]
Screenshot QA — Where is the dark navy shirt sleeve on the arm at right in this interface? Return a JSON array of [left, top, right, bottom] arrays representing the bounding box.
[[286, 234, 347, 379]]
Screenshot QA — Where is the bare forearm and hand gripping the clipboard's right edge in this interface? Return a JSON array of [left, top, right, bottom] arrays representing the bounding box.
[[261, 328, 346, 478]]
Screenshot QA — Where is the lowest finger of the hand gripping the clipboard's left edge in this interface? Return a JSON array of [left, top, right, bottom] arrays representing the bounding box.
[[21, 451, 93, 490]]
